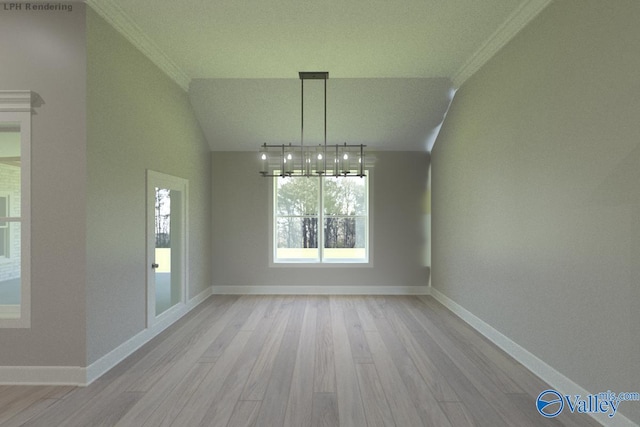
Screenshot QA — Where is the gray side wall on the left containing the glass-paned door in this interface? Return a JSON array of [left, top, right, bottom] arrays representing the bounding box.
[[87, 11, 211, 364]]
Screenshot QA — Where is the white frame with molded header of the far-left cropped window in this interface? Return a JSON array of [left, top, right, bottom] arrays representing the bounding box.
[[0, 90, 32, 328]]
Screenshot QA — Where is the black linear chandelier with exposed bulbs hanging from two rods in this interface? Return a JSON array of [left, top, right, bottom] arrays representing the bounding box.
[[260, 71, 366, 177]]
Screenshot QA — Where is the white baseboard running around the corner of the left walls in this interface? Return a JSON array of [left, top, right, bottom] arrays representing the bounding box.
[[0, 287, 212, 386]]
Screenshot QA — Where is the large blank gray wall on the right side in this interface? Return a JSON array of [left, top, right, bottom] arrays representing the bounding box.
[[432, 0, 640, 422]]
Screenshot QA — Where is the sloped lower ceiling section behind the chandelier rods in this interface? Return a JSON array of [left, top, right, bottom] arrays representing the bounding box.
[[189, 78, 452, 151]]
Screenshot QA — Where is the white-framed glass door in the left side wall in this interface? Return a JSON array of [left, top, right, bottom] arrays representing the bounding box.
[[147, 170, 189, 327]]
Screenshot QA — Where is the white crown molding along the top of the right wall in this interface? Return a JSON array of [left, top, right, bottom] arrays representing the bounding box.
[[451, 0, 552, 88]]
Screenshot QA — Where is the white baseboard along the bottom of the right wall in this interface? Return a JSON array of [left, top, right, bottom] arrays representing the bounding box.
[[431, 288, 637, 427]]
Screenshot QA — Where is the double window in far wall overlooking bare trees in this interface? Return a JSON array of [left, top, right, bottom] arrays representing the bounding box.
[[273, 174, 369, 263]]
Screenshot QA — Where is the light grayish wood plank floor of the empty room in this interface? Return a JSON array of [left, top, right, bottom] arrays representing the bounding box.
[[0, 296, 597, 427]]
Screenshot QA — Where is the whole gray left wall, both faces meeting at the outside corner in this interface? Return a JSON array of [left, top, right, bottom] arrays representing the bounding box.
[[0, 3, 211, 366]]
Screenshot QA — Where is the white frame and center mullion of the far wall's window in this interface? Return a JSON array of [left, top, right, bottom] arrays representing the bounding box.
[[269, 169, 373, 267]]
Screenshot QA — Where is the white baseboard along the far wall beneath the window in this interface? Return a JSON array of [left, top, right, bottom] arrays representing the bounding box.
[[212, 285, 430, 295]]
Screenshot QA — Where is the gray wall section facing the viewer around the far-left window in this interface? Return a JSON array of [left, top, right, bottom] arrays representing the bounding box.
[[0, 3, 86, 366]]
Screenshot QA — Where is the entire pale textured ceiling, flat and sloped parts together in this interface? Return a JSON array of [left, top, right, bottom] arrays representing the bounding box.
[[88, 0, 550, 150]]
